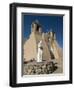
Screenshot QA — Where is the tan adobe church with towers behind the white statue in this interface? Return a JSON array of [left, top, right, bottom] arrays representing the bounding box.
[[23, 21, 63, 63]]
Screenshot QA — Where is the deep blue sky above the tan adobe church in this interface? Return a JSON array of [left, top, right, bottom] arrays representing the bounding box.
[[22, 14, 63, 47]]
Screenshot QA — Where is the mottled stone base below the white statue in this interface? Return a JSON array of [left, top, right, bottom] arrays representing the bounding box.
[[23, 61, 58, 75]]
